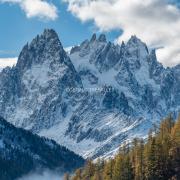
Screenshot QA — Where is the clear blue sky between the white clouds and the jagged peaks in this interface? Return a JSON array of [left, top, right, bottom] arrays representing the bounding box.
[[0, 0, 120, 58]]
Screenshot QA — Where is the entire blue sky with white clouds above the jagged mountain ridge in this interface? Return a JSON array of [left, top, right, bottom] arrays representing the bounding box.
[[0, 0, 180, 68]]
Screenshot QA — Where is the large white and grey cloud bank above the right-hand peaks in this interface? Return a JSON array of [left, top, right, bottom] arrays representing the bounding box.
[[64, 0, 180, 66]]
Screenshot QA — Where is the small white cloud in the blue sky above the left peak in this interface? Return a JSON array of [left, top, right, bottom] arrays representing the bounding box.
[[0, 0, 58, 20]]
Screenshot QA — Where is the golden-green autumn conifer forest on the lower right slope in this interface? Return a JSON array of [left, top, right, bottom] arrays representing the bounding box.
[[64, 115, 180, 180]]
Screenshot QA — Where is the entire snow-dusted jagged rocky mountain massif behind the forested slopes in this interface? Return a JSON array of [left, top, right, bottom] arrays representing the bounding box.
[[0, 29, 180, 158]]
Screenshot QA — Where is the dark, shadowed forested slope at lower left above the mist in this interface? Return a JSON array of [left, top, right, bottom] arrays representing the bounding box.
[[0, 117, 84, 180]]
